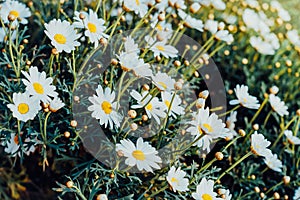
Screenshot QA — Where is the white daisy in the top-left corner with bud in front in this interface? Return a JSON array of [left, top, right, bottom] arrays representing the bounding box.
[[0, 0, 31, 26]]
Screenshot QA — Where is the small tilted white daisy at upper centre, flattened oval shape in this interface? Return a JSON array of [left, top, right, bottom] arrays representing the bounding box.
[[150, 40, 178, 58]]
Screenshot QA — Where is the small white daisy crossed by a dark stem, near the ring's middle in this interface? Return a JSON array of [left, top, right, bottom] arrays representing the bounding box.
[[161, 91, 184, 118]]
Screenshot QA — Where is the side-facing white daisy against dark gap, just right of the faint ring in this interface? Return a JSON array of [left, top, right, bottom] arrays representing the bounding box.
[[229, 85, 260, 109]]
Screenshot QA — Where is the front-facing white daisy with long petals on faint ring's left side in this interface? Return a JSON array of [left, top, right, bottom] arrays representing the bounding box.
[[88, 85, 122, 128]]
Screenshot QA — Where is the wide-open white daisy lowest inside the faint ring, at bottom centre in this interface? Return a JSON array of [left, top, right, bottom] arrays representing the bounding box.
[[116, 137, 162, 172]]
